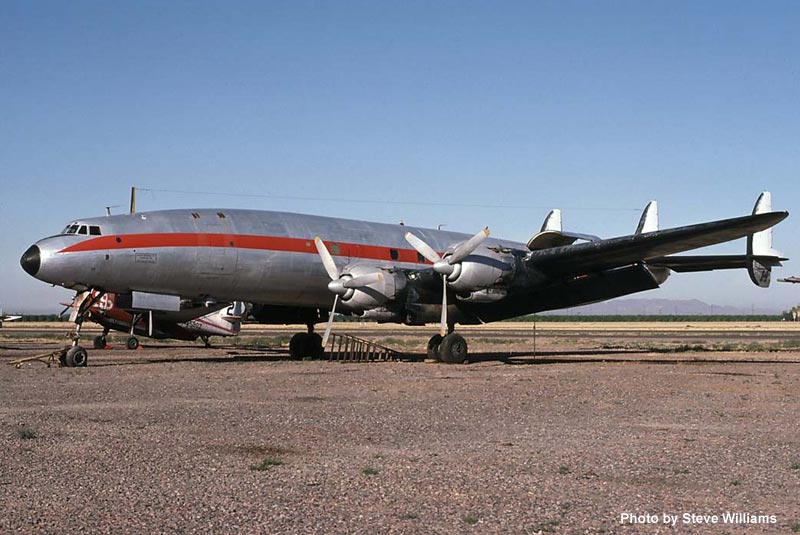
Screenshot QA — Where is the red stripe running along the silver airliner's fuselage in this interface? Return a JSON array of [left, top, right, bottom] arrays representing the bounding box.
[[59, 232, 427, 264]]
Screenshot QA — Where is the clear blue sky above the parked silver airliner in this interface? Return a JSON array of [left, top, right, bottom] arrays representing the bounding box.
[[0, 0, 800, 311]]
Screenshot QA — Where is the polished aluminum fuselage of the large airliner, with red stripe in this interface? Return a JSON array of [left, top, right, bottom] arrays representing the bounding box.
[[35, 209, 525, 308]]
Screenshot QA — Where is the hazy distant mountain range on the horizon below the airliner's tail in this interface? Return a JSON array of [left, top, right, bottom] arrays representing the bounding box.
[[544, 299, 779, 316]]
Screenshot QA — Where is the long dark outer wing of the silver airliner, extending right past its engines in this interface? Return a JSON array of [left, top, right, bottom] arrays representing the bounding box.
[[525, 212, 789, 275]]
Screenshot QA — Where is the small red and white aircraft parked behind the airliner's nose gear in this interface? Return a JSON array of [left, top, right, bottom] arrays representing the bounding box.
[[65, 290, 248, 349]]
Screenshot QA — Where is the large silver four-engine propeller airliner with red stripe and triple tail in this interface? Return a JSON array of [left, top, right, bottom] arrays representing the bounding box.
[[20, 192, 788, 363]]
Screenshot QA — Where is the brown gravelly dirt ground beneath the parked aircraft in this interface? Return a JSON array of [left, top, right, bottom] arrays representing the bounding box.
[[0, 323, 800, 534]]
